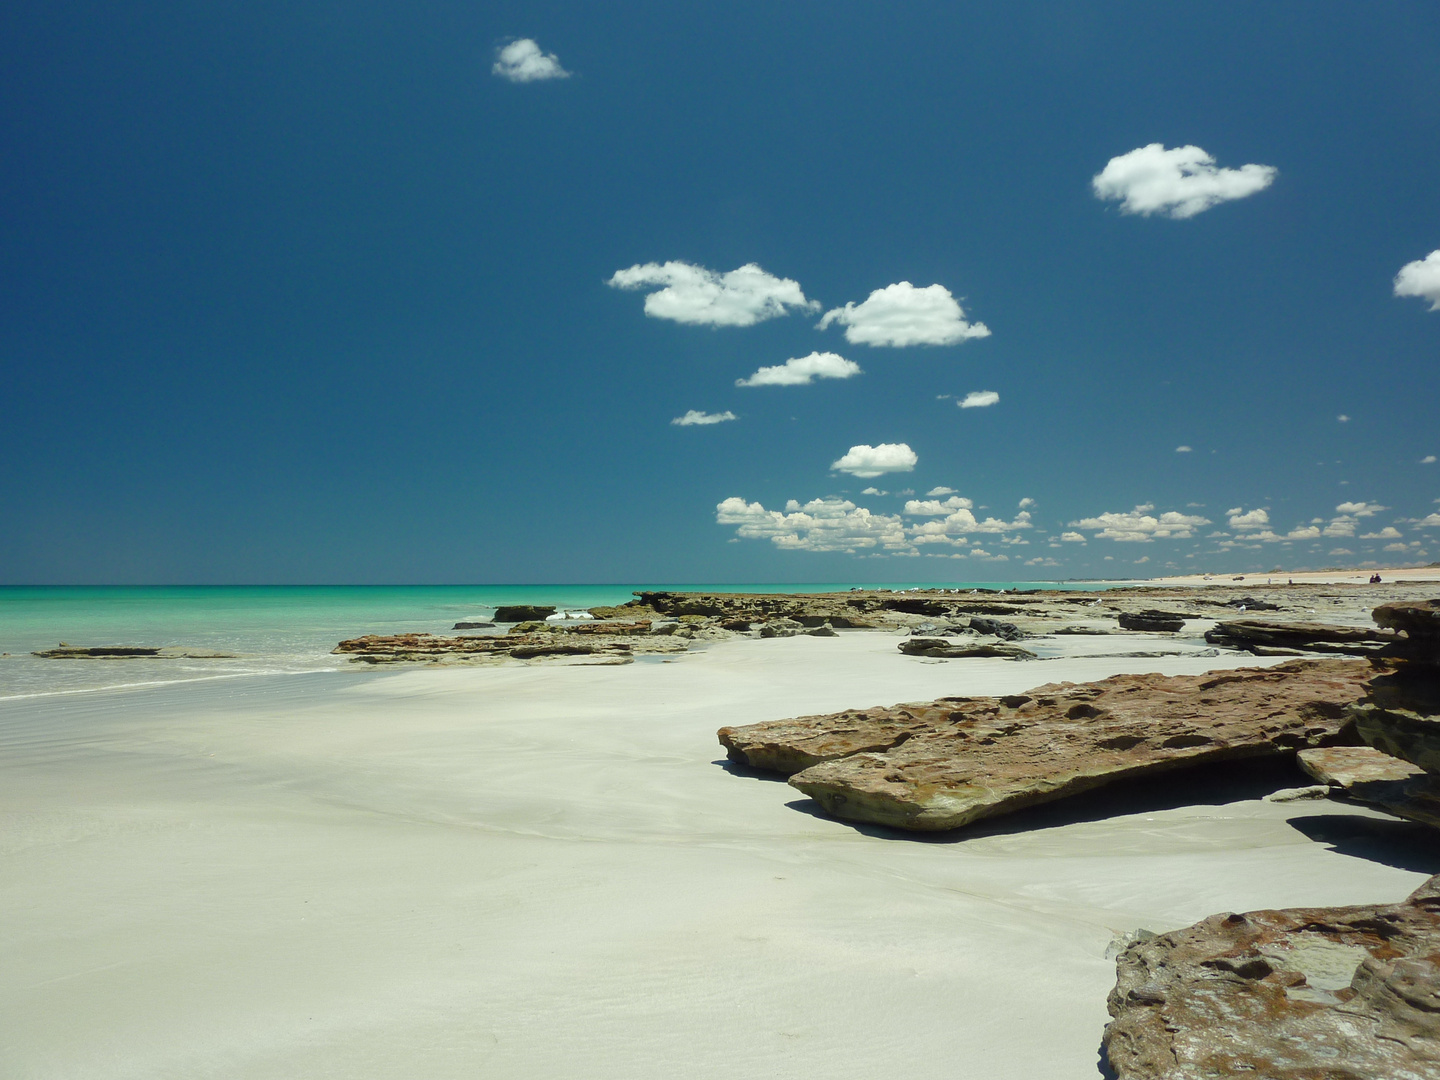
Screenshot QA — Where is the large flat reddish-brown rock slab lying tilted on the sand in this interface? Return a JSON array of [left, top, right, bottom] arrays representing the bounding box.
[[719, 660, 1371, 831]]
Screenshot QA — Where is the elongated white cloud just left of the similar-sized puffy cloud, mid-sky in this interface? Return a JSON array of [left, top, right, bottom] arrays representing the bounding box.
[[605, 261, 819, 327]]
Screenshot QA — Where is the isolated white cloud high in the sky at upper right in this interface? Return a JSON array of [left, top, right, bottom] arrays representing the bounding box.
[[1092, 143, 1277, 217]]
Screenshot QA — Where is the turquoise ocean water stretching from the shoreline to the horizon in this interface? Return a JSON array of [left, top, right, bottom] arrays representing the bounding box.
[[0, 582, 1116, 701]]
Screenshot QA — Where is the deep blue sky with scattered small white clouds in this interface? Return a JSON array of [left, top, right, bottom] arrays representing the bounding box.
[[0, 0, 1440, 583]]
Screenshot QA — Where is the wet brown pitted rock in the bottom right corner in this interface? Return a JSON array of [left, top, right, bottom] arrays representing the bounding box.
[[1103, 877, 1440, 1080]]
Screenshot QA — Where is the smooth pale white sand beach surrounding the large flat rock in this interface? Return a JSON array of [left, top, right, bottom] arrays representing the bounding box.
[[0, 632, 1440, 1080]]
